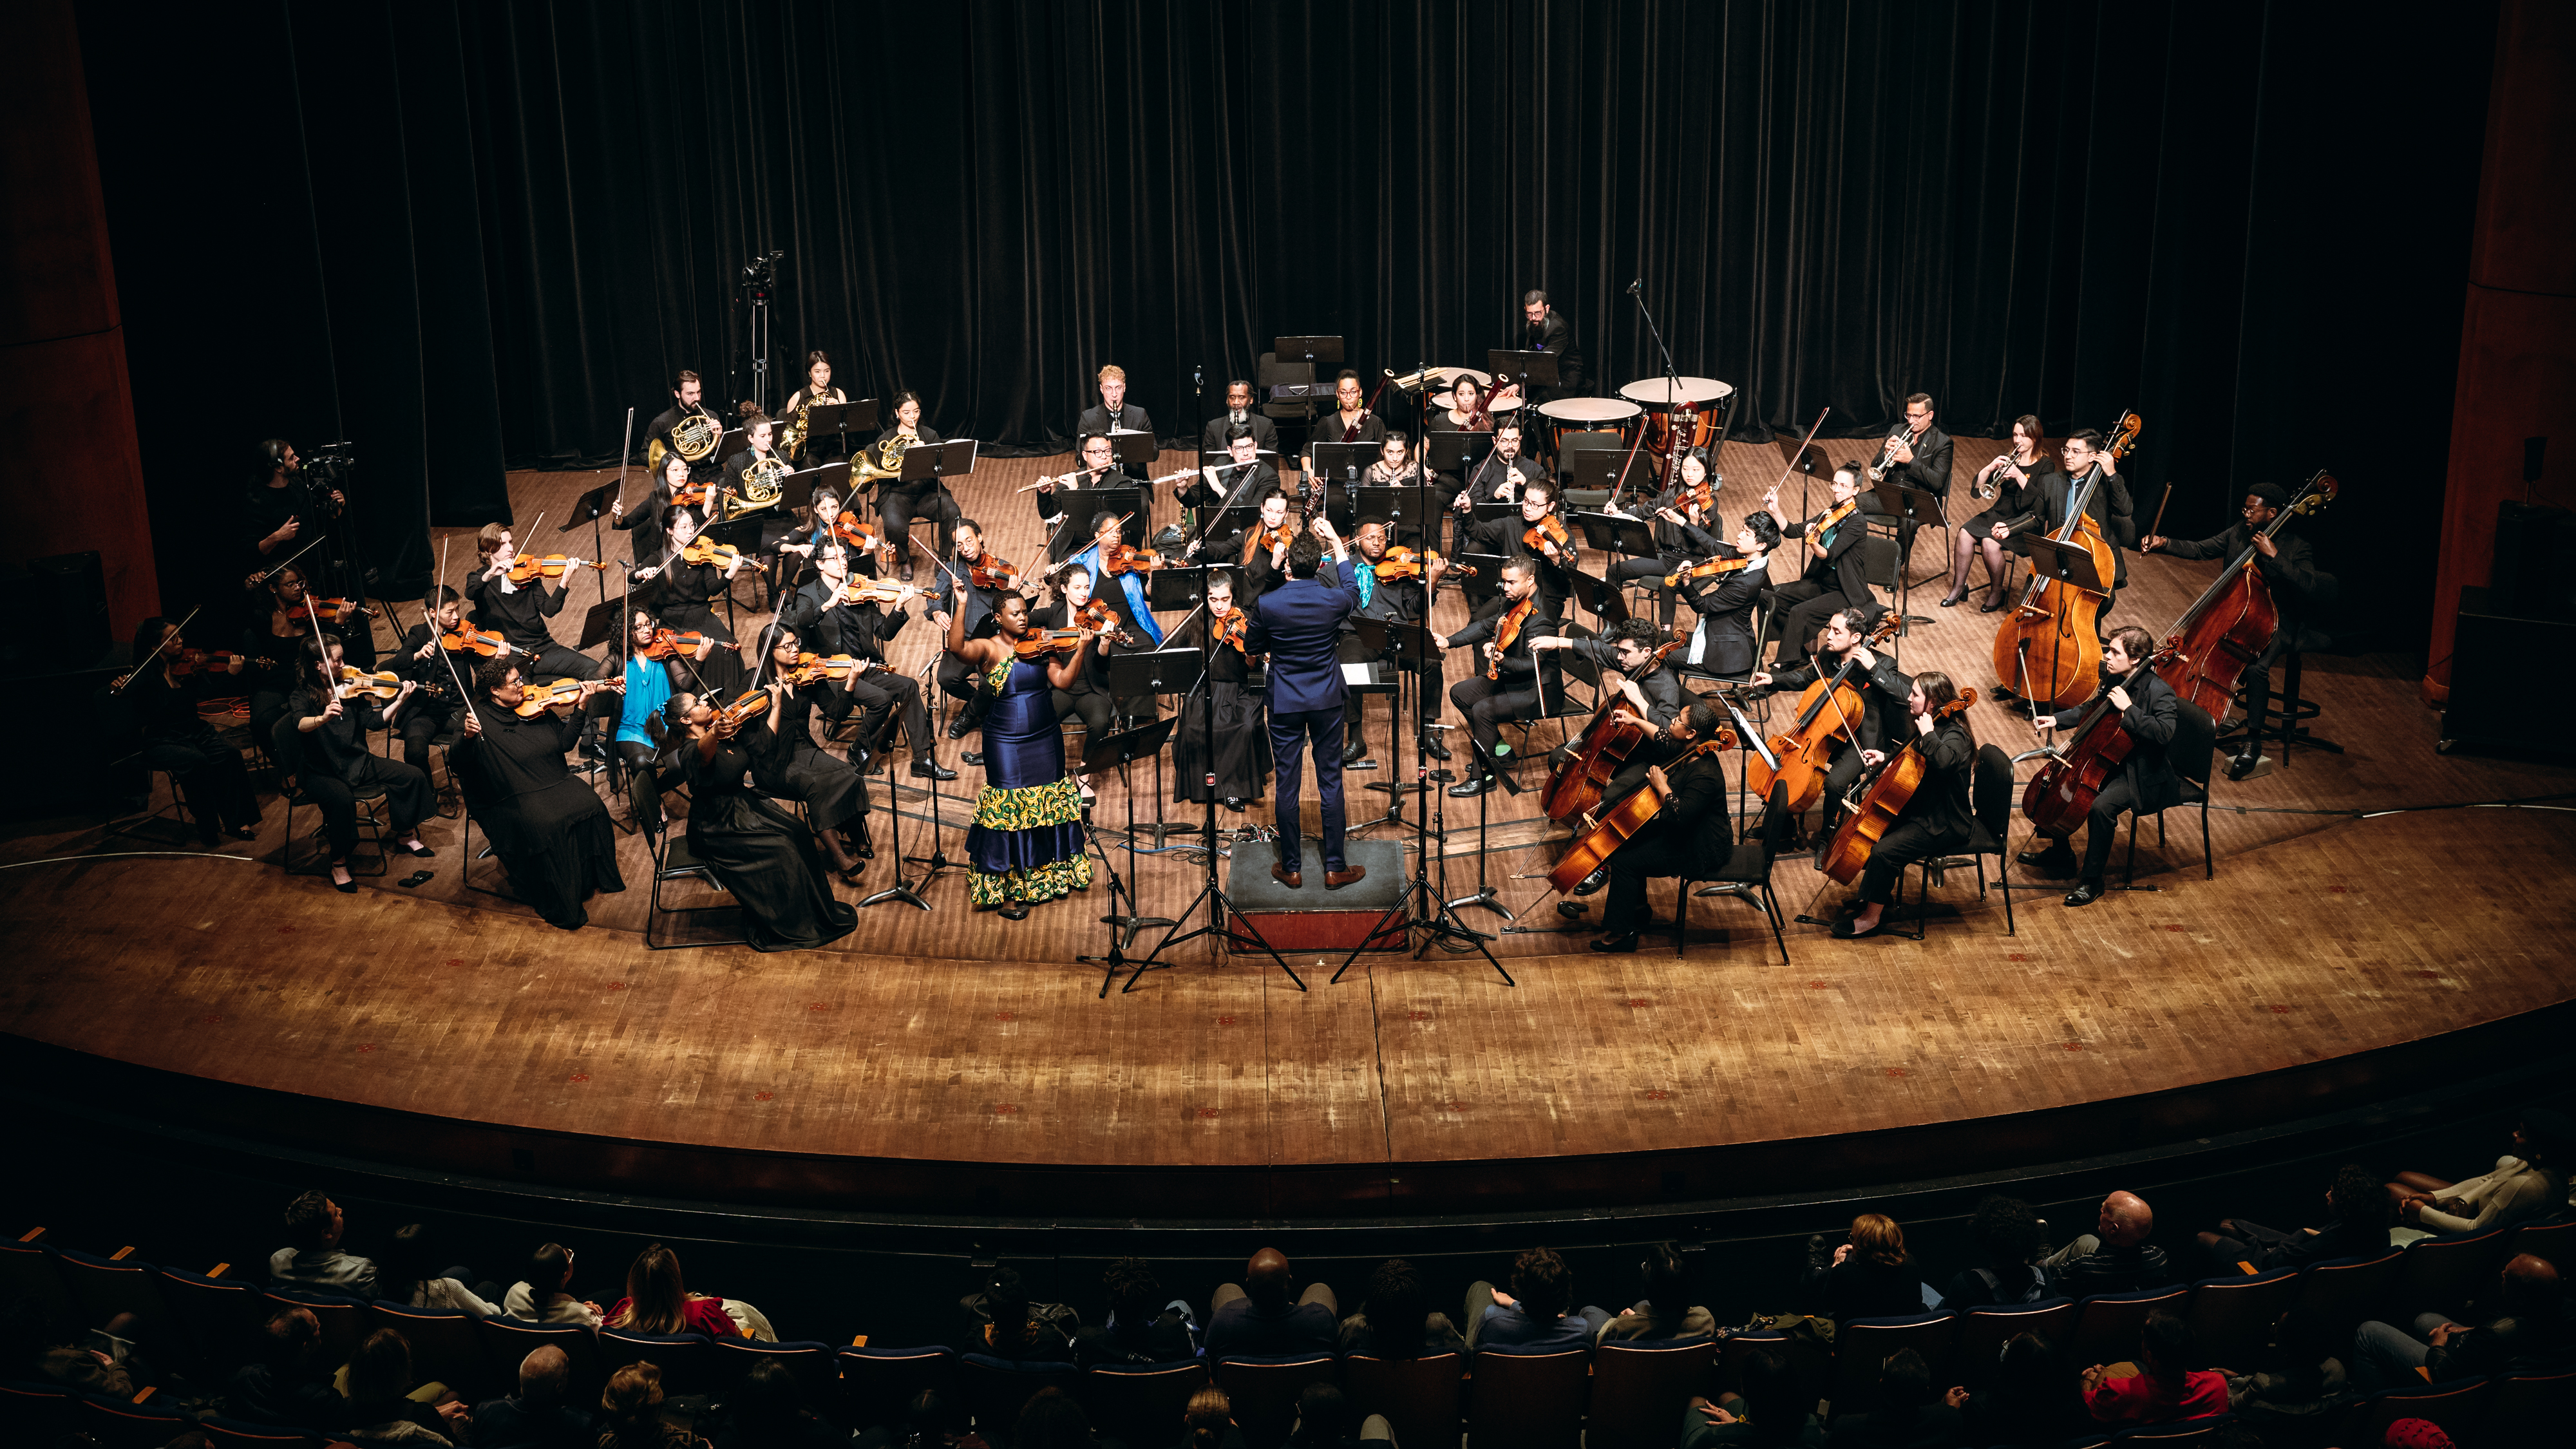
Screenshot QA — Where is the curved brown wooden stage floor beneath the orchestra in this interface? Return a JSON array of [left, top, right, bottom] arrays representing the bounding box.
[[0, 441, 2576, 1217]]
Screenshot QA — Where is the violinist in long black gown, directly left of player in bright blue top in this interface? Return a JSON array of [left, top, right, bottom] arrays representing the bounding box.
[[451, 658, 626, 931]]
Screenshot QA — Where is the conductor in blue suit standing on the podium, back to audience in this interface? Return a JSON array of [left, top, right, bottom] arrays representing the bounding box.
[[1244, 518, 1368, 889]]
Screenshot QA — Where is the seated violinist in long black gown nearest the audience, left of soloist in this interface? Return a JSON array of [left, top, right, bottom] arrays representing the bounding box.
[[670, 694, 858, 951]]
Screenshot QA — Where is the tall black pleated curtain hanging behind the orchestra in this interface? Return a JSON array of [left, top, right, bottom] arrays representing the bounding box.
[[85, 0, 2494, 631]]
